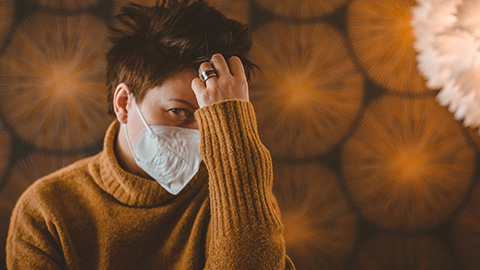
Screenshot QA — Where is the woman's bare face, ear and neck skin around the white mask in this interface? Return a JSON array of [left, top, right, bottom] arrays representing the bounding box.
[[114, 70, 198, 178]]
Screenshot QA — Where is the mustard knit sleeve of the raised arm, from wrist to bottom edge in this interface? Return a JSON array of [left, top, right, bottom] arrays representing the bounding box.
[[195, 100, 294, 269]]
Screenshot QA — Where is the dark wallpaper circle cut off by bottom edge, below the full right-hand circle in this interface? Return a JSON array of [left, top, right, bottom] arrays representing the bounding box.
[[351, 236, 457, 270]]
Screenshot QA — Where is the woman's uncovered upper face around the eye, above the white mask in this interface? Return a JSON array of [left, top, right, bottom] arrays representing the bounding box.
[[129, 70, 198, 133]]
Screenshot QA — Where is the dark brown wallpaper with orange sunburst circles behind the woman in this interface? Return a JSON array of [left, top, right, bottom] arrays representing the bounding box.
[[0, 0, 480, 269]]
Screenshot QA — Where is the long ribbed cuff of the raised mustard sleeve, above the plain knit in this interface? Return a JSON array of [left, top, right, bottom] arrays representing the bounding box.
[[195, 100, 281, 236]]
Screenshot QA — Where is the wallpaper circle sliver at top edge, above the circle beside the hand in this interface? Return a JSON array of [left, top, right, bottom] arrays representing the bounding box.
[[251, 0, 347, 19]]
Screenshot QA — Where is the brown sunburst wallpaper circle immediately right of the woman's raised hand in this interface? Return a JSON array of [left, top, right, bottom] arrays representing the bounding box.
[[250, 22, 364, 158]]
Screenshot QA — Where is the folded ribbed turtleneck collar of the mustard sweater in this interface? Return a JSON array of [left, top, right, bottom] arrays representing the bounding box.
[[90, 120, 208, 207]]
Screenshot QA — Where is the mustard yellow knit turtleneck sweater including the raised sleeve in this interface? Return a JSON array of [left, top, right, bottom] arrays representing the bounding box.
[[7, 100, 294, 270]]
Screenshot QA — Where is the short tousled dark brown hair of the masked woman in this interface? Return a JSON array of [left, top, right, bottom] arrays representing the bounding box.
[[107, 0, 255, 113]]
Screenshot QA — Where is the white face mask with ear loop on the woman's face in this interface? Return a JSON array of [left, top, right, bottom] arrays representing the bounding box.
[[123, 96, 202, 195]]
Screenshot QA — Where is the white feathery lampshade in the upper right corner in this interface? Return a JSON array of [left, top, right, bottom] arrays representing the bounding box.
[[411, 0, 480, 127]]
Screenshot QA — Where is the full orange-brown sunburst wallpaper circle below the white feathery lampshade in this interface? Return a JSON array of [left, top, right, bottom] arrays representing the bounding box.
[[342, 96, 475, 231]]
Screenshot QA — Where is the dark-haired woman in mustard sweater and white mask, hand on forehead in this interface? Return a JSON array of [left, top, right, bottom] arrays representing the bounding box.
[[7, 0, 294, 269]]
